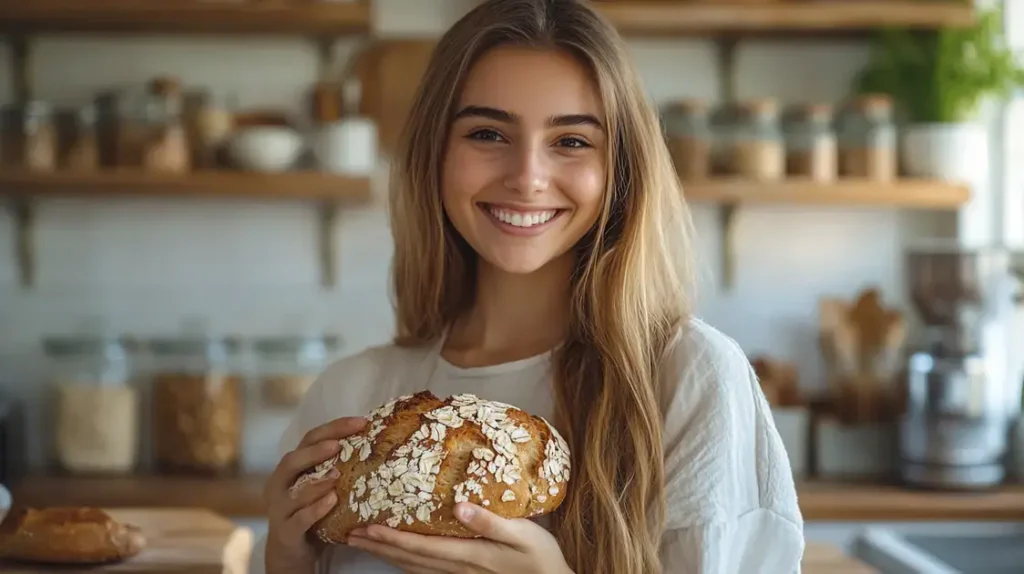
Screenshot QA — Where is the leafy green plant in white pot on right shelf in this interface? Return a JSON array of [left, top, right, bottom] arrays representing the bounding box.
[[854, 8, 1024, 181]]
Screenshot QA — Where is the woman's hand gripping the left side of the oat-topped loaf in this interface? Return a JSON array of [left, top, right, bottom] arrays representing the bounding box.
[[263, 417, 367, 574]]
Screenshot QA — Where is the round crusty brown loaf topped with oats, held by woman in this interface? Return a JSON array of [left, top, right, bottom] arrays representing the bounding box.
[[292, 391, 570, 544]]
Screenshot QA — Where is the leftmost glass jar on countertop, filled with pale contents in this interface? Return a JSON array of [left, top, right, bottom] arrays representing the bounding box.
[[44, 337, 139, 474]]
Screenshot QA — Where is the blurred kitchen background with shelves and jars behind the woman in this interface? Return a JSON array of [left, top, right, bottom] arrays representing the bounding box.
[[0, 0, 1024, 574]]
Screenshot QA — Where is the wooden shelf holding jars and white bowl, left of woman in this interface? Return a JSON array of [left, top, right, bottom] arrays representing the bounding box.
[[0, 170, 371, 203]]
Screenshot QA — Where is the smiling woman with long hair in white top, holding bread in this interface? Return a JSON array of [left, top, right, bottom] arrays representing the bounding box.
[[254, 0, 804, 574]]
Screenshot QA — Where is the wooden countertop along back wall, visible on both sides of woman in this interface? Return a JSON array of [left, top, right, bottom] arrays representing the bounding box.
[[12, 476, 1024, 522]]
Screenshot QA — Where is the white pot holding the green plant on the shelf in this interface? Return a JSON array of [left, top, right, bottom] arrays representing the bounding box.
[[900, 123, 988, 183]]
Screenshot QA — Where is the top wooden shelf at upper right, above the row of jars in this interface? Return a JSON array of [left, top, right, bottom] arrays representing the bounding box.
[[598, 0, 974, 35]]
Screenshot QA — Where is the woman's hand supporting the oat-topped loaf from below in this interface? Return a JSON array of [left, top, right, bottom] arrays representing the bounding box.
[[348, 502, 571, 574]]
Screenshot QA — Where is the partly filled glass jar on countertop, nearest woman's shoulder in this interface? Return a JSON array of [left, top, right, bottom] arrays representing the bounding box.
[[253, 336, 338, 408]]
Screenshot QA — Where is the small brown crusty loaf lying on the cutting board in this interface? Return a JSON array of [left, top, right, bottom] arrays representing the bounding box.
[[0, 506, 145, 565]]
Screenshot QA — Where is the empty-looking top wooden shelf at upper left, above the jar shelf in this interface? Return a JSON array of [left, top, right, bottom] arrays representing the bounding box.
[[0, 0, 371, 36]]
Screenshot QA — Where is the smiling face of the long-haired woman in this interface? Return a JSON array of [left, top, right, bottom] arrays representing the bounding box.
[[441, 48, 607, 273]]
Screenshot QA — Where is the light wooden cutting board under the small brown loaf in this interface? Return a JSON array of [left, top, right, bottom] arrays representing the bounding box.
[[0, 509, 253, 574]]
